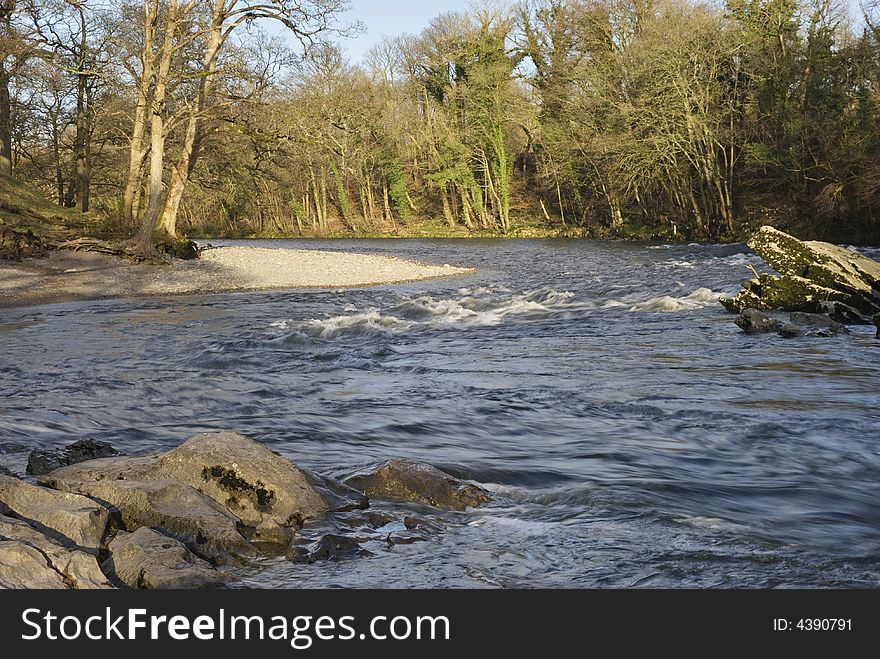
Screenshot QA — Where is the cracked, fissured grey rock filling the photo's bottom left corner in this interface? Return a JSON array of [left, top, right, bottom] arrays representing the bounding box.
[[0, 515, 112, 588]]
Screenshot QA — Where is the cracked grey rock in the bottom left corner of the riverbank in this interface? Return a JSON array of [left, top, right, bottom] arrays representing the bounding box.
[[0, 515, 112, 588]]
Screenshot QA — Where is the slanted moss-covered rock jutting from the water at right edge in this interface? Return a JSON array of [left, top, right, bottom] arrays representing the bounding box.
[[720, 226, 880, 322]]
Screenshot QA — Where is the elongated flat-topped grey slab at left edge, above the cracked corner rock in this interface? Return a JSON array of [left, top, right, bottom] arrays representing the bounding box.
[[0, 476, 109, 551]]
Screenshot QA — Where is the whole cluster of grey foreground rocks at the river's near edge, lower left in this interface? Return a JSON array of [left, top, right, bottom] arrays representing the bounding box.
[[0, 432, 489, 588]]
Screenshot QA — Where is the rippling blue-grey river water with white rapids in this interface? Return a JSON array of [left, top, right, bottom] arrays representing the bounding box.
[[0, 240, 880, 588]]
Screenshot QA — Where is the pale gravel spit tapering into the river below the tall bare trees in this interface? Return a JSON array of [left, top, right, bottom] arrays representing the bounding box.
[[0, 247, 473, 307]]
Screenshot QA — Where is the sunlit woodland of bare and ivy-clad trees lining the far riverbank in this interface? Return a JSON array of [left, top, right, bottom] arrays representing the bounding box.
[[10, 0, 880, 242]]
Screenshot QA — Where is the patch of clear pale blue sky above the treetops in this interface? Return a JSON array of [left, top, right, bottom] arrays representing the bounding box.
[[341, 0, 469, 64]]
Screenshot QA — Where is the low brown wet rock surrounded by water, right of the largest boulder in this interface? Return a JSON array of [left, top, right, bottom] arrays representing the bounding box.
[[345, 460, 490, 510]]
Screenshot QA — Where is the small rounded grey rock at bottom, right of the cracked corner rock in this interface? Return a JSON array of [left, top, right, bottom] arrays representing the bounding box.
[[104, 527, 223, 589]]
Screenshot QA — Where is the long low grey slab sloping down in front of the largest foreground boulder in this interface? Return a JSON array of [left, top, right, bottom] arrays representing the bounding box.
[[41, 472, 254, 563]]
